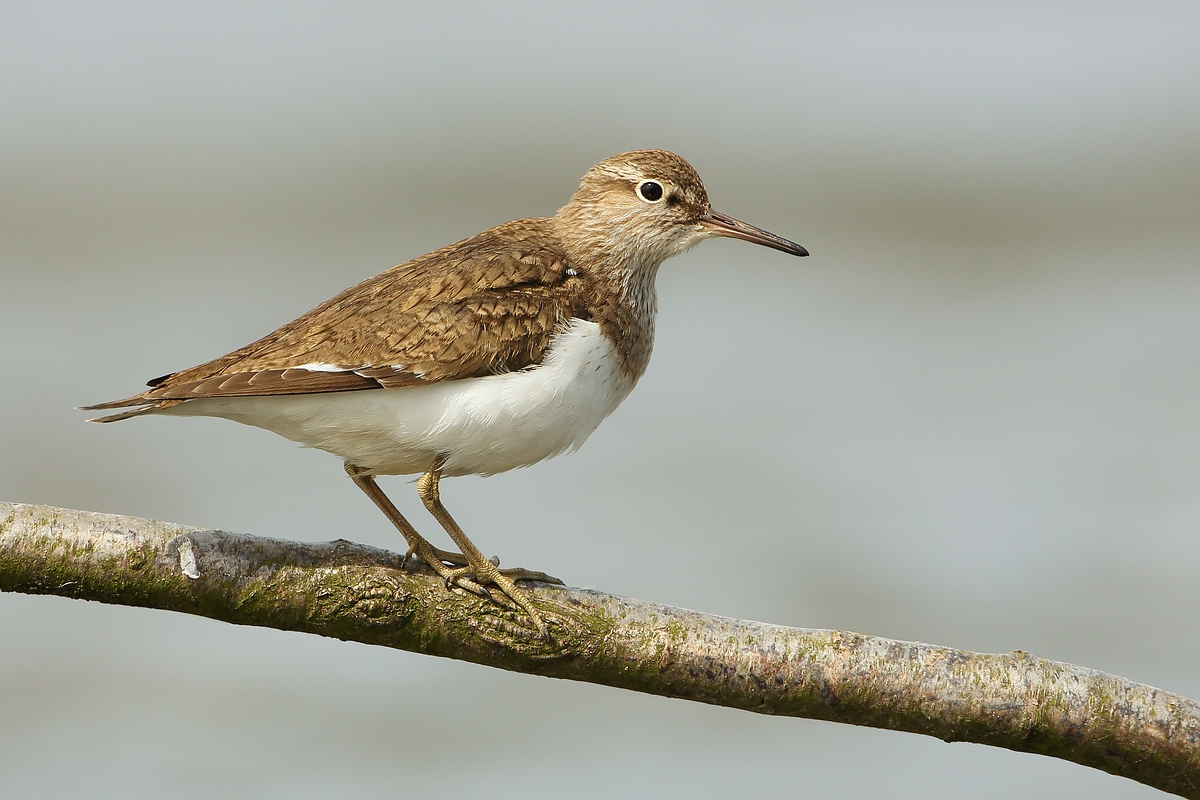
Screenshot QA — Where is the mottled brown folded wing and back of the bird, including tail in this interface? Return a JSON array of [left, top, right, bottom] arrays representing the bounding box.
[[89, 219, 586, 419]]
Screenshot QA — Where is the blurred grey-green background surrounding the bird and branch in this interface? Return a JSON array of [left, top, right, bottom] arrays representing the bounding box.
[[0, 1, 1200, 799]]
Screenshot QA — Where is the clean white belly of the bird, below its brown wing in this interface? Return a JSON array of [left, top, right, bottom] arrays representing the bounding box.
[[166, 319, 637, 475]]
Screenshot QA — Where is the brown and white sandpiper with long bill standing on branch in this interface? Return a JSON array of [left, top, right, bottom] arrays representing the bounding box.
[[84, 150, 809, 640]]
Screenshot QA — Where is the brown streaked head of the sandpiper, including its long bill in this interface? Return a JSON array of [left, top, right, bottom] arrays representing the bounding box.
[[554, 150, 809, 273]]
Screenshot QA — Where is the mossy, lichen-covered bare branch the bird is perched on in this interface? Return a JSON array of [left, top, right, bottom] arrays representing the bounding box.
[[0, 503, 1200, 799]]
